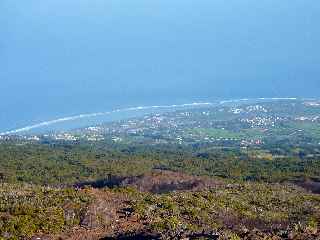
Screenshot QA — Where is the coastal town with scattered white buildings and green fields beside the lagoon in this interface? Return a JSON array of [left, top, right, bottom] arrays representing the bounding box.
[[0, 101, 320, 147]]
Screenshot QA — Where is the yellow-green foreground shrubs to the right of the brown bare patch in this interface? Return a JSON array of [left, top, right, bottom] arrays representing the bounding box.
[[122, 183, 320, 239]]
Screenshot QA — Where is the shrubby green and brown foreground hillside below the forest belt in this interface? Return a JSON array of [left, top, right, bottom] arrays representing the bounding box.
[[0, 171, 320, 240]]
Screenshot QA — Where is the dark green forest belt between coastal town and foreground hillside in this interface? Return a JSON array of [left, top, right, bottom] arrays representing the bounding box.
[[0, 140, 320, 186]]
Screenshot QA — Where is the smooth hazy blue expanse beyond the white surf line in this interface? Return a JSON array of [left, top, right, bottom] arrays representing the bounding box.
[[0, 0, 320, 132]]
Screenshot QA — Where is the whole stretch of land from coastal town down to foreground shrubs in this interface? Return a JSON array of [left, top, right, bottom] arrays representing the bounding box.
[[0, 99, 320, 240]]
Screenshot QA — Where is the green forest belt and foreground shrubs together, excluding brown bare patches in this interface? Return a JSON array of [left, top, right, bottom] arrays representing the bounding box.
[[0, 142, 320, 239]]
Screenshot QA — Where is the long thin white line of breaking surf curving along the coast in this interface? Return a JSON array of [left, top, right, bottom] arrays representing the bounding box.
[[0, 98, 297, 136]]
